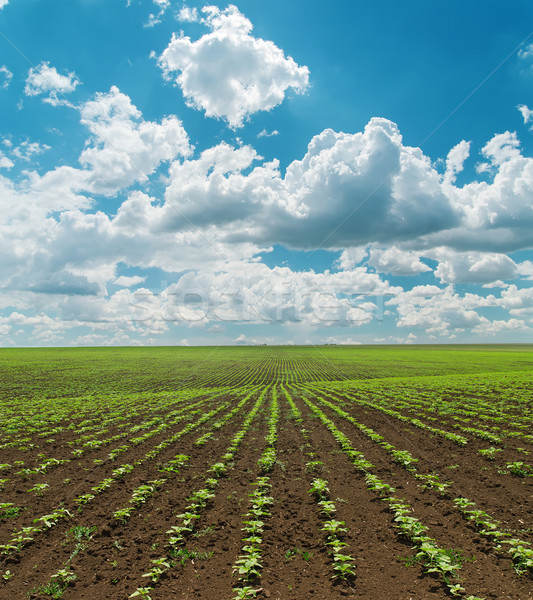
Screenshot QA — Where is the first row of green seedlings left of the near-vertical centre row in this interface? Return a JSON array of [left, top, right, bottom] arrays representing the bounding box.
[[130, 388, 268, 600]]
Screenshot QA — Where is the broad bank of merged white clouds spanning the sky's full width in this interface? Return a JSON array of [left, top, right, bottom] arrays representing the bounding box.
[[0, 87, 533, 343]]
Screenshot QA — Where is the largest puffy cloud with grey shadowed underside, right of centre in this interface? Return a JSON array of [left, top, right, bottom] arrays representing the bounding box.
[[160, 118, 459, 248]]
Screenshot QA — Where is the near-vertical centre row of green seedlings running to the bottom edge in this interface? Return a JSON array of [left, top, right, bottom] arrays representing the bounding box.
[[233, 387, 279, 600]]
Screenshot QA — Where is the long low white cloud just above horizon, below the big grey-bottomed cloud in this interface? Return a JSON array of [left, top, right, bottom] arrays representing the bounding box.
[[116, 262, 401, 327]]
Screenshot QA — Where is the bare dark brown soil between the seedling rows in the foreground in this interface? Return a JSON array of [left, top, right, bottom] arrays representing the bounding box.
[[0, 389, 533, 600]]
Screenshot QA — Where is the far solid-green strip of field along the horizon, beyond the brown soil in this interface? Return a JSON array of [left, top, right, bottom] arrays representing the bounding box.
[[0, 344, 533, 398]]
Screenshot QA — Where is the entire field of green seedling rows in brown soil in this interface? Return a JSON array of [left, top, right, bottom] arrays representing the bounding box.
[[0, 346, 533, 600]]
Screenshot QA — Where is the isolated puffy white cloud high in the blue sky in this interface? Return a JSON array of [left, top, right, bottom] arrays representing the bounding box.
[[158, 5, 309, 128]]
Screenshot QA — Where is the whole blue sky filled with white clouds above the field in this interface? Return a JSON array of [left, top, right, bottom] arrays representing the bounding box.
[[0, 0, 533, 346]]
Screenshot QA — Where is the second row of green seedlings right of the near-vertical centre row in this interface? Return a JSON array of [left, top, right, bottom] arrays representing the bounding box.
[[302, 396, 482, 600]]
